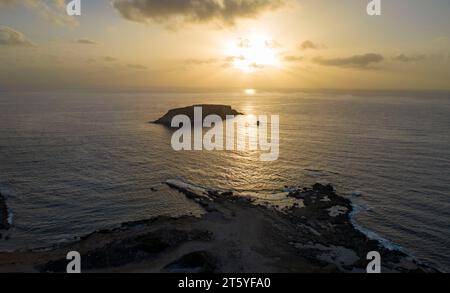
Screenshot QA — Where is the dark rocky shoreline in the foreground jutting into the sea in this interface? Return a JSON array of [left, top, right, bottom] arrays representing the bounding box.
[[0, 180, 437, 273]]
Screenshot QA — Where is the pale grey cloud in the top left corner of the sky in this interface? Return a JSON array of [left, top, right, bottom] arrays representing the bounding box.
[[0, 0, 79, 27]]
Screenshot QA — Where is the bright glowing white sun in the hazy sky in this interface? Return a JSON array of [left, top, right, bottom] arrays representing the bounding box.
[[225, 34, 281, 73]]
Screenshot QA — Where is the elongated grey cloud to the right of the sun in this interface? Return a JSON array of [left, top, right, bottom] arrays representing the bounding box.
[[313, 53, 384, 69]]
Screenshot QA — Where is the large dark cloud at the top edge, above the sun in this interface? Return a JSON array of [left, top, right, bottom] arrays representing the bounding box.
[[113, 0, 287, 26]]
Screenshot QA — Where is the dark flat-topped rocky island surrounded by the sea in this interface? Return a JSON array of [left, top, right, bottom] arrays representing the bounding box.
[[153, 104, 243, 127]]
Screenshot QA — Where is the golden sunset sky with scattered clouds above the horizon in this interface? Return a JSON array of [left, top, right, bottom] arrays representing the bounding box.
[[0, 0, 450, 90]]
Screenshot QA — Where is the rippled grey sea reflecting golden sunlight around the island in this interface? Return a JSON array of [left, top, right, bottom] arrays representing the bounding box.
[[0, 92, 450, 271]]
